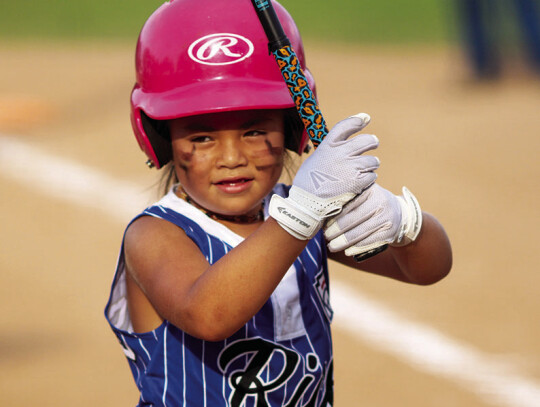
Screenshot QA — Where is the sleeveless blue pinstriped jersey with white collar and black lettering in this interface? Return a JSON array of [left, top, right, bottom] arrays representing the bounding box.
[[105, 184, 333, 407]]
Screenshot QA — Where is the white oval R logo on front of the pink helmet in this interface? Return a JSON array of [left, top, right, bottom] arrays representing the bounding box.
[[188, 33, 254, 65]]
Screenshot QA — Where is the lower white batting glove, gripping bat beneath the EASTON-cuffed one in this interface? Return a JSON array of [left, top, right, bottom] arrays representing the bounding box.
[[324, 184, 422, 259]]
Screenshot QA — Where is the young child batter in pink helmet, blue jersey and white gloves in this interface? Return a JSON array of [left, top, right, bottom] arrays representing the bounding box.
[[106, 0, 451, 407]]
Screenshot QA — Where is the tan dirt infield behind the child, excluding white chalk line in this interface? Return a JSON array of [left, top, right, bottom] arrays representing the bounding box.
[[0, 43, 540, 407]]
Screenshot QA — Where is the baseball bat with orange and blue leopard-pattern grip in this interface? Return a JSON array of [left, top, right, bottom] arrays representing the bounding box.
[[251, 0, 388, 261]]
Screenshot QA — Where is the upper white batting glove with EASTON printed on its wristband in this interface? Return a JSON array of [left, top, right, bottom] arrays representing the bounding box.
[[269, 113, 379, 240]]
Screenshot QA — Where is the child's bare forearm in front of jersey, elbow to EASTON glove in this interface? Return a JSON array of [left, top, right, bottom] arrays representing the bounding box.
[[180, 218, 307, 340]]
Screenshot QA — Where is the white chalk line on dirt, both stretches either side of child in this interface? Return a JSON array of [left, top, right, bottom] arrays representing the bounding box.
[[0, 135, 540, 407]]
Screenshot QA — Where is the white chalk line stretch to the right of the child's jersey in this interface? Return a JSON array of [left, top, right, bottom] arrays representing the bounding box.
[[331, 280, 540, 407]]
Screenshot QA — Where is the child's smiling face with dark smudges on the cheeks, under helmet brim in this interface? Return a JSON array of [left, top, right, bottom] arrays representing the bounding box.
[[170, 110, 285, 215]]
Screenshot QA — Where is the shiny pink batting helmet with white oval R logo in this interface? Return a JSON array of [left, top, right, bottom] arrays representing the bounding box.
[[131, 0, 315, 168]]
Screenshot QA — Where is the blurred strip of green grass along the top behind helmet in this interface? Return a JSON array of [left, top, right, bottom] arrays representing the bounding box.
[[0, 0, 451, 43]]
